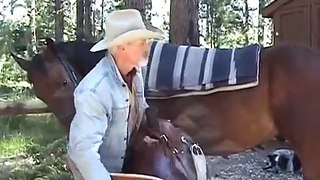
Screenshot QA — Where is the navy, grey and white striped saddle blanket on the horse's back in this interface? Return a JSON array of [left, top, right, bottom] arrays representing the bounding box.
[[144, 41, 261, 97]]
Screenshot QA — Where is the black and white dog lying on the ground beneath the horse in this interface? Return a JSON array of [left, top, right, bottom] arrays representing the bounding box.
[[263, 149, 302, 173]]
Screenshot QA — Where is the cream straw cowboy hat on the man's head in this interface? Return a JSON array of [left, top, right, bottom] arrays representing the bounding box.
[[90, 9, 161, 52]]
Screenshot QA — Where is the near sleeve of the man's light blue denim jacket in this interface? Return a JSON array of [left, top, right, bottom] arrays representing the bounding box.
[[68, 90, 111, 180]]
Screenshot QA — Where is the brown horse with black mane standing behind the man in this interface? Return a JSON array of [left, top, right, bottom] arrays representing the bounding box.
[[10, 37, 320, 180]]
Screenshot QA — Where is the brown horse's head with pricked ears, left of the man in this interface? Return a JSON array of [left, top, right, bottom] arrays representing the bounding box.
[[11, 38, 83, 134]]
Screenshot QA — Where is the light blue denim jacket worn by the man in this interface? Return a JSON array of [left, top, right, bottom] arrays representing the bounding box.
[[68, 51, 148, 180]]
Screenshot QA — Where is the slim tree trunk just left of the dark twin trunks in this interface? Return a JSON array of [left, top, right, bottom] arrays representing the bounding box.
[[55, 0, 64, 42]]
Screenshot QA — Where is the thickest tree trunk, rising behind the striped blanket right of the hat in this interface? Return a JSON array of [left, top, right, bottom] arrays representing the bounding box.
[[169, 0, 200, 46]]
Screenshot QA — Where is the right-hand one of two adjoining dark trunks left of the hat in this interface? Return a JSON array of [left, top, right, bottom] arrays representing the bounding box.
[[84, 0, 93, 41]]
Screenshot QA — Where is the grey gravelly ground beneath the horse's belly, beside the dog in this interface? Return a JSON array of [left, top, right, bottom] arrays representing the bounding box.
[[207, 150, 302, 180]]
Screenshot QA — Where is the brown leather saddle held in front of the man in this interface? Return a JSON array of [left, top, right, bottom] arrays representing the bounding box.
[[123, 108, 207, 180]]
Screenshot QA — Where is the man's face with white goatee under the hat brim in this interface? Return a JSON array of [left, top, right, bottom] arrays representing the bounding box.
[[124, 40, 149, 66]]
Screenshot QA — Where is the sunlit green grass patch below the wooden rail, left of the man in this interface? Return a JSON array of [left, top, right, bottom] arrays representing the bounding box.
[[0, 114, 71, 180]]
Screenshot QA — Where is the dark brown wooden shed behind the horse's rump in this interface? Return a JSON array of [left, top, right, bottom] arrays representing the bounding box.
[[262, 0, 320, 49]]
